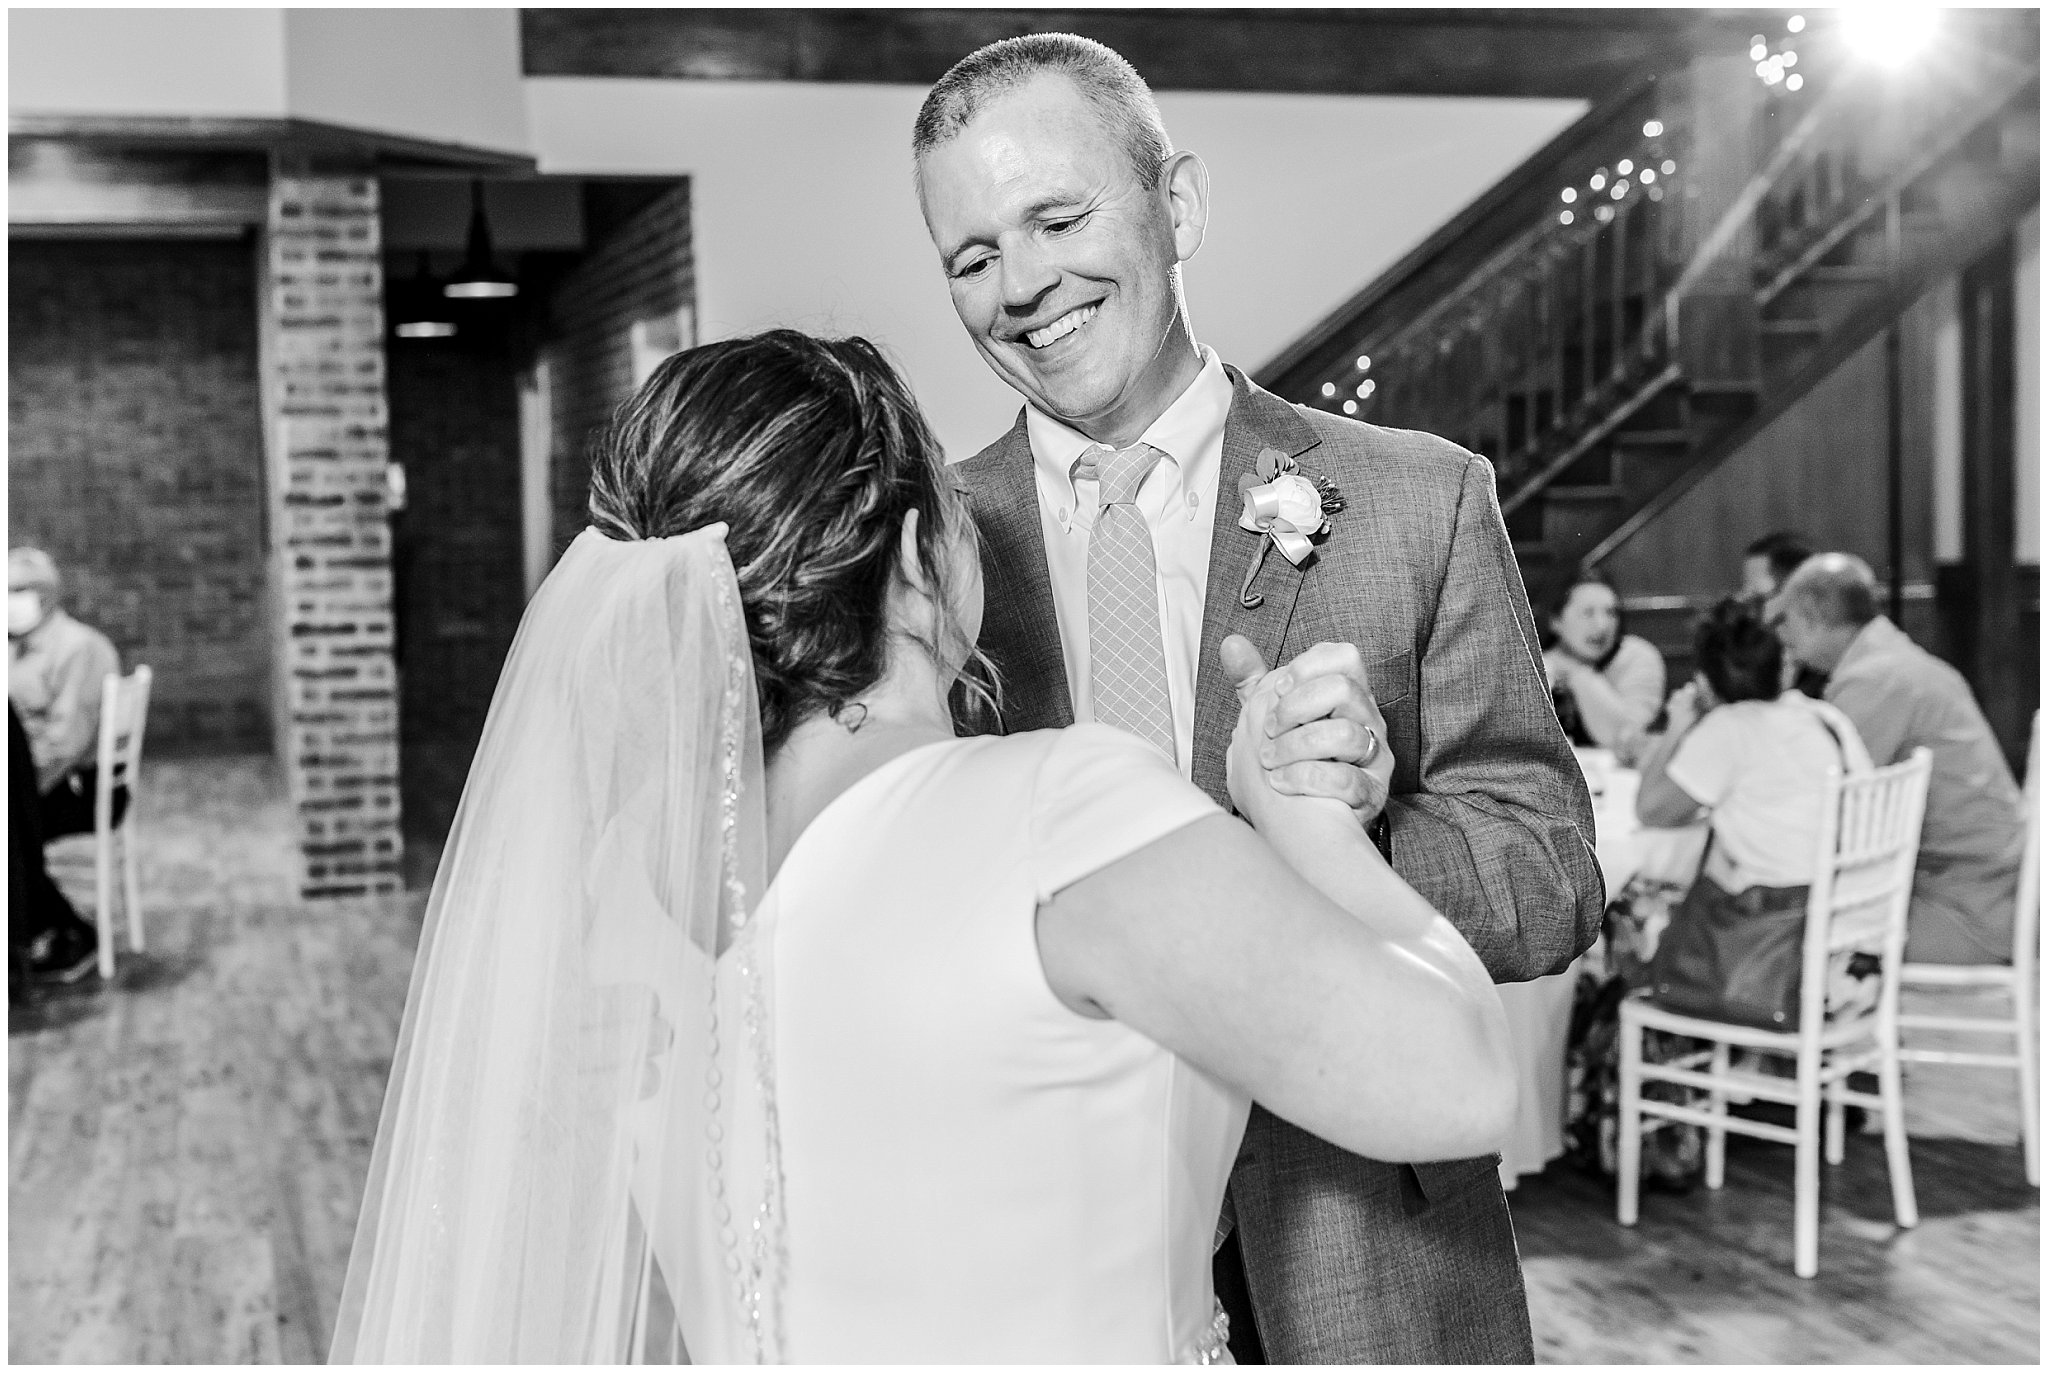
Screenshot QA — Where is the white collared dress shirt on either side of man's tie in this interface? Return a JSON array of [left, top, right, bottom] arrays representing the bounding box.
[[1024, 346, 1231, 777]]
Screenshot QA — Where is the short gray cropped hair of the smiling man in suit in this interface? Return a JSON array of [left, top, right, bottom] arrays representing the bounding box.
[[909, 33, 1174, 186]]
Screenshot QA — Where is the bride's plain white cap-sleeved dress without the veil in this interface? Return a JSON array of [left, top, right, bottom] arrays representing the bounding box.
[[678, 725, 1249, 1363]]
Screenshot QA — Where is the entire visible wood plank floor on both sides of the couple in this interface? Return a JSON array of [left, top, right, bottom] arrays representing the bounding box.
[[8, 760, 2040, 1363]]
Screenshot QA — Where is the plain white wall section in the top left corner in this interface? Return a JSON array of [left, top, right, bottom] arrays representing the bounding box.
[[6, 8, 285, 119]]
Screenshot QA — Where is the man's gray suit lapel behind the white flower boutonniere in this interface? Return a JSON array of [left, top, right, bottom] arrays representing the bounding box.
[[1194, 367, 1321, 807]]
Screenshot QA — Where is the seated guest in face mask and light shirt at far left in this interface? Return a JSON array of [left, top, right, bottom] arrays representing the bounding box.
[[6, 547, 127, 982]]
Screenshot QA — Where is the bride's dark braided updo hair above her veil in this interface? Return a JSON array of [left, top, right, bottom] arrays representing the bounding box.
[[590, 330, 993, 754]]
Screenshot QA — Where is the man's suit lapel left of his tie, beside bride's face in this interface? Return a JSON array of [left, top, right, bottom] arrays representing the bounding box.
[[963, 410, 1073, 734]]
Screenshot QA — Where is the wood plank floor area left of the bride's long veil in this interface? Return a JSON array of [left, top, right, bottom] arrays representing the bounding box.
[[8, 758, 422, 1363]]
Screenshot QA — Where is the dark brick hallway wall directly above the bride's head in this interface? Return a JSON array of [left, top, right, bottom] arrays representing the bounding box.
[[547, 182, 696, 551]]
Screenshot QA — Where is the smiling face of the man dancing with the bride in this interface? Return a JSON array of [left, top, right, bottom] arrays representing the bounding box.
[[920, 74, 1208, 443]]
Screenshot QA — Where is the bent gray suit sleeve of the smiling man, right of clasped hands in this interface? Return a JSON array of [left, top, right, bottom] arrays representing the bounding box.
[[1386, 457, 1606, 982]]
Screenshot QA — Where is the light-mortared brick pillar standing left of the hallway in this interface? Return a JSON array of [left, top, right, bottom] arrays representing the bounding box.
[[262, 164, 401, 898]]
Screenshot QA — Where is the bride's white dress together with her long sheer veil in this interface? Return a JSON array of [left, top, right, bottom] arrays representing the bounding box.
[[330, 525, 1249, 1365]]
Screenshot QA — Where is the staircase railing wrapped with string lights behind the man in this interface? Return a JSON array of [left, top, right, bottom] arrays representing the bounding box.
[[1268, 33, 2038, 528]]
